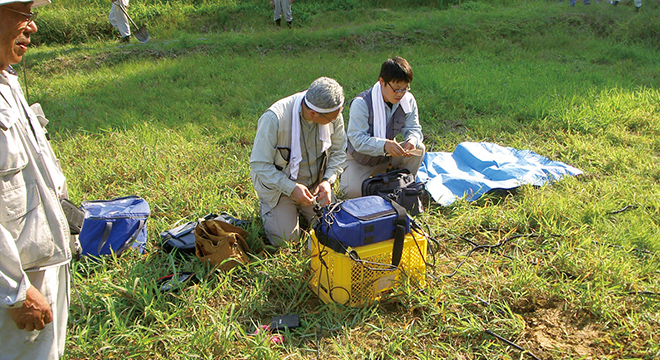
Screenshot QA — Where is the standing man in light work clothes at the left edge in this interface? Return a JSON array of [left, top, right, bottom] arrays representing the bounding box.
[[0, 0, 72, 360]]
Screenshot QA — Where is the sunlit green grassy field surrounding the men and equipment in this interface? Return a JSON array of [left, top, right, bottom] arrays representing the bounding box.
[[17, 0, 660, 359]]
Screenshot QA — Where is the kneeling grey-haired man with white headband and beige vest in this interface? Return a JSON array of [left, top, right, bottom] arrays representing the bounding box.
[[250, 77, 346, 246]]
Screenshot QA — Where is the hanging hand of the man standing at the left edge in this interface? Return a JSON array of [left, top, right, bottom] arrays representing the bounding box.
[[7, 285, 53, 331]]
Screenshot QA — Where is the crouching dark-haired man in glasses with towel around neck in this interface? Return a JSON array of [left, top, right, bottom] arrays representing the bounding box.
[[340, 56, 425, 198]]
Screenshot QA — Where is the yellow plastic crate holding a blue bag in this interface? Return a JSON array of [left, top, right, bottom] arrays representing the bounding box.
[[309, 231, 427, 307]]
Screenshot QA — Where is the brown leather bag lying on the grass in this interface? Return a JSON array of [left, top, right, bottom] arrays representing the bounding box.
[[195, 220, 250, 271]]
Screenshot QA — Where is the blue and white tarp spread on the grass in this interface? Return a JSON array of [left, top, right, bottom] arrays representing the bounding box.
[[417, 142, 582, 206]]
